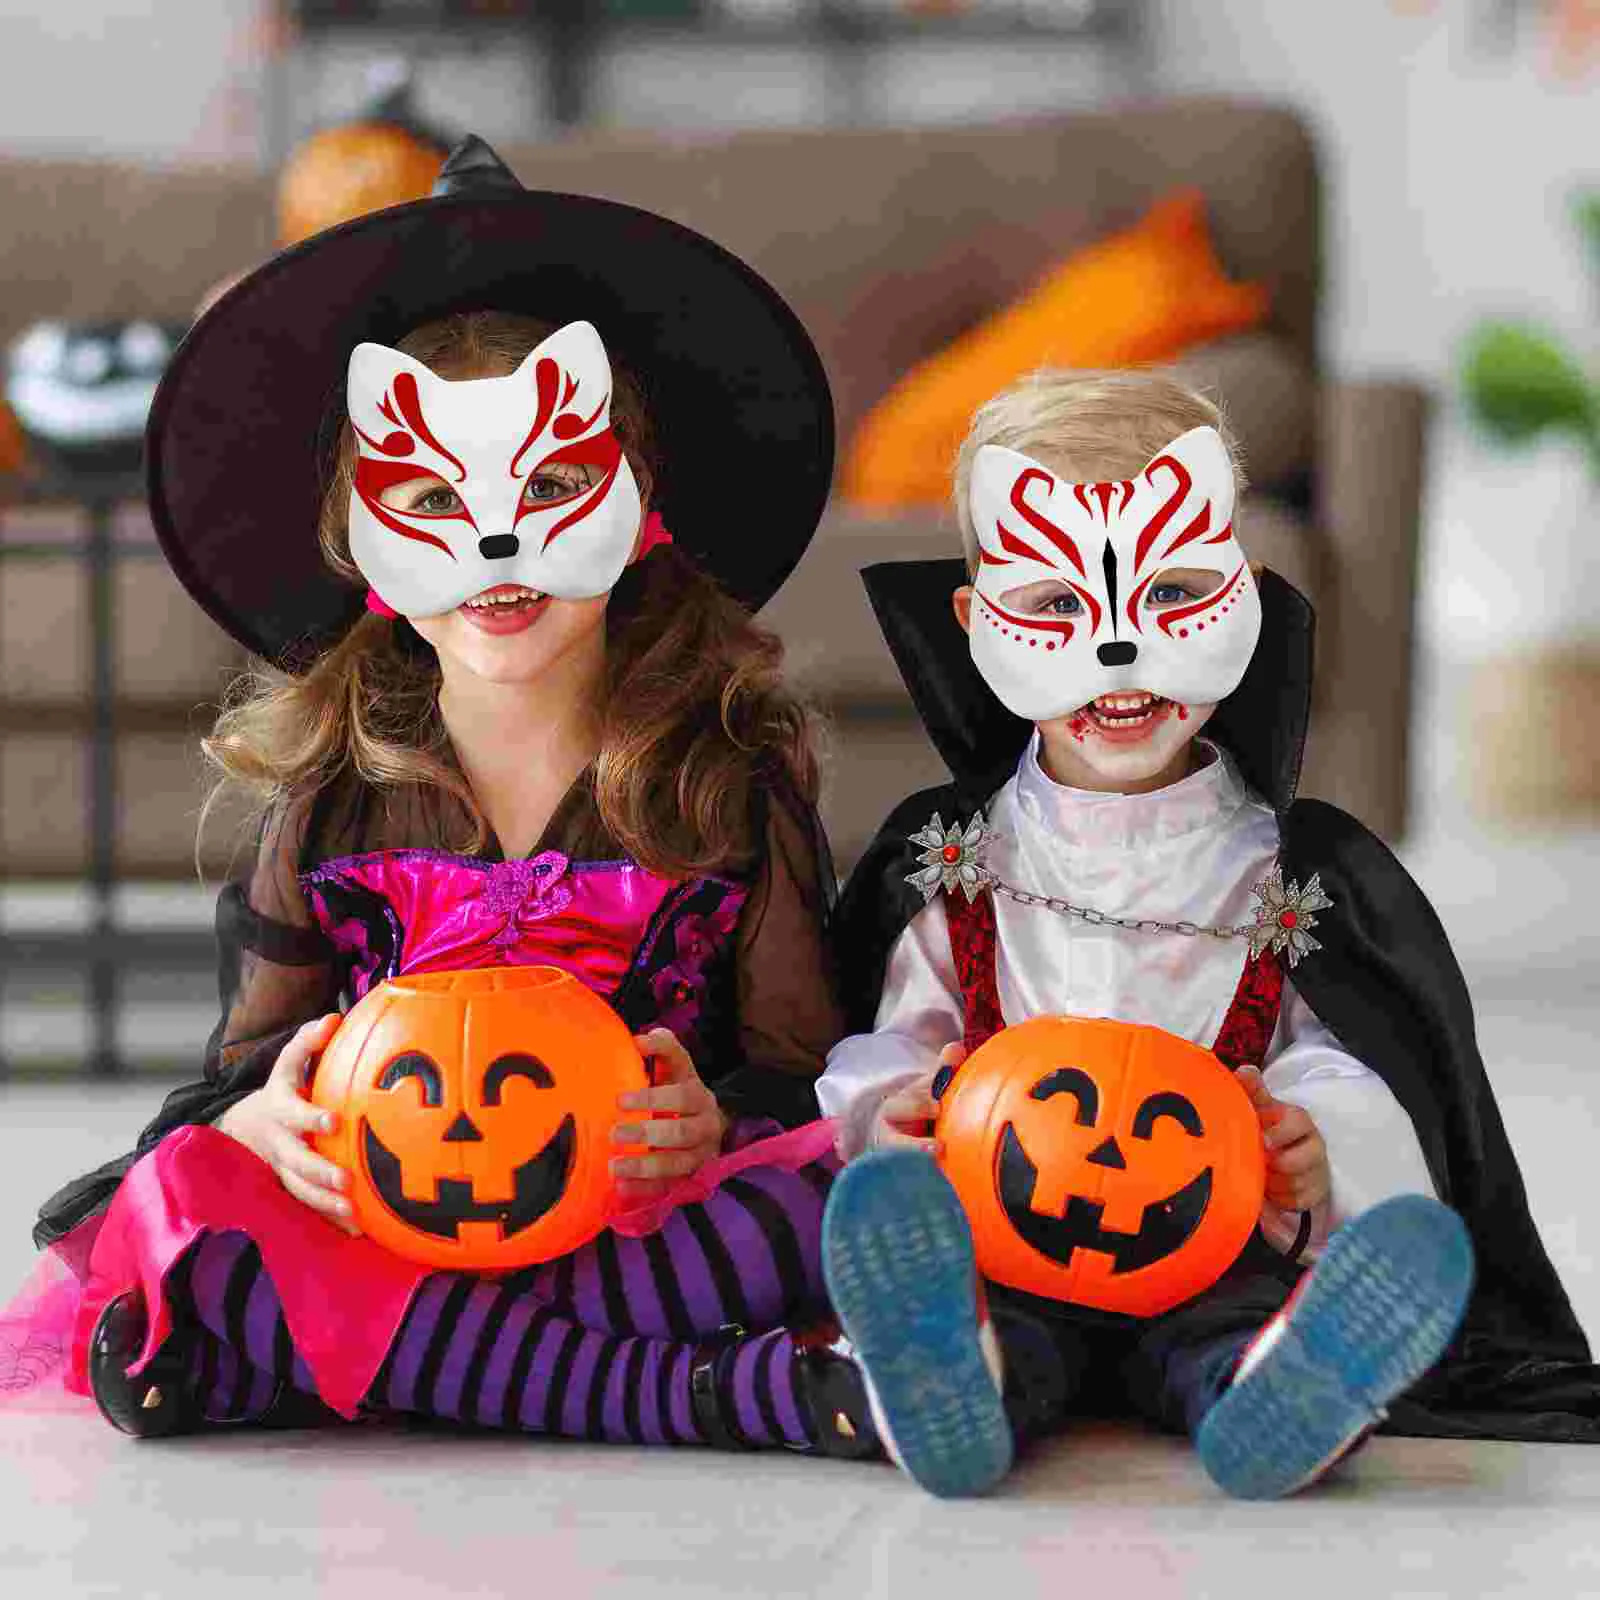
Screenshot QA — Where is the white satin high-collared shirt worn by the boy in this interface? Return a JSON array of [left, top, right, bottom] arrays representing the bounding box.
[[816, 733, 1434, 1256]]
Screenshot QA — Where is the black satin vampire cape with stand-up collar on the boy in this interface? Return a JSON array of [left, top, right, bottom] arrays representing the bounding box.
[[835, 562, 1600, 1443]]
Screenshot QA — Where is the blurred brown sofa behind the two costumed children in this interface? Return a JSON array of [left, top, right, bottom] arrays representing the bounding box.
[[0, 101, 1426, 875]]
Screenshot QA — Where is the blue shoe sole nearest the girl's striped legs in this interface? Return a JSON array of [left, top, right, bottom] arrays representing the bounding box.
[[822, 1150, 1011, 1498]]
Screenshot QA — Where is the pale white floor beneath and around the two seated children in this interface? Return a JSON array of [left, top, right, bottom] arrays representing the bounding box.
[[0, 752, 1600, 1600]]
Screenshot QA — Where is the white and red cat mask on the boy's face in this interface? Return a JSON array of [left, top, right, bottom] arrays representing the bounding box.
[[968, 427, 1261, 722]]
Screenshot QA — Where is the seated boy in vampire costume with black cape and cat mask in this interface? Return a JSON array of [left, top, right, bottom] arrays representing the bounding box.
[[818, 373, 1600, 1498]]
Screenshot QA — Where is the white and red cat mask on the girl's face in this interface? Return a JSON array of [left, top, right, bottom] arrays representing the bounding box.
[[346, 322, 642, 616]]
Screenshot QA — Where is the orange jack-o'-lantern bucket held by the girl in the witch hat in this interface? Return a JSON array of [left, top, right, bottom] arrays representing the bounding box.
[[312, 966, 646, 1272]]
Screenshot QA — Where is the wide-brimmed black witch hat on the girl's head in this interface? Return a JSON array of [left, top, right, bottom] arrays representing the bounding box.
[[146, 138, 834, 666]]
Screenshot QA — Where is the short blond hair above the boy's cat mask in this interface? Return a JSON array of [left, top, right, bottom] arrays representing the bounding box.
[[955, 368, 1245, 574]]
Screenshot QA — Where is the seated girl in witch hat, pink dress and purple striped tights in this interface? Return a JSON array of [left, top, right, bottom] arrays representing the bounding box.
[[9, 141, 947, 1454]]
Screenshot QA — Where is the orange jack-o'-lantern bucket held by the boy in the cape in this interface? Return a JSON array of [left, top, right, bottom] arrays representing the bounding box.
[[936, 1018, 1266, 1317]]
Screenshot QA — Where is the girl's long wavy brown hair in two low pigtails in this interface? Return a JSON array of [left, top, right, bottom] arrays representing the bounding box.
[[202, 312, 818, 877]]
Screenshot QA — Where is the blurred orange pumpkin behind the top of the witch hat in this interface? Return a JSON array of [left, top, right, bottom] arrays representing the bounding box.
[[278, 120, 445, 245]]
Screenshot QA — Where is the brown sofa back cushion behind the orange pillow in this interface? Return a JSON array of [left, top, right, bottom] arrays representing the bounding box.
[[507, 99, 1318, 438]]
